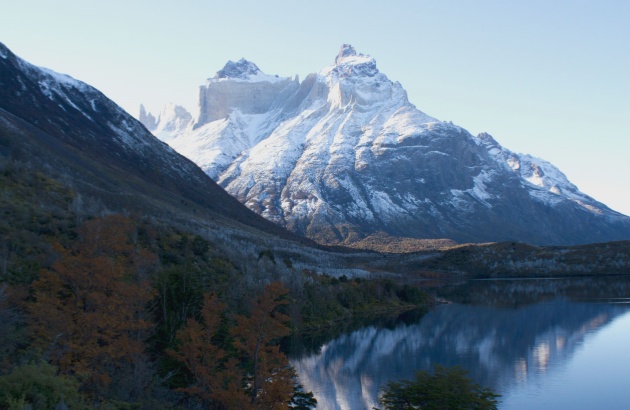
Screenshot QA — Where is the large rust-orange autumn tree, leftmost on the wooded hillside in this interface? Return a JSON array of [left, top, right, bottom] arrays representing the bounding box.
[[30, 216, 156, 397]]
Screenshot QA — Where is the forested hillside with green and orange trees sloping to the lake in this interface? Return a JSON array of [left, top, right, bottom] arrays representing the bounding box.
[[0, 160, 426, 409]]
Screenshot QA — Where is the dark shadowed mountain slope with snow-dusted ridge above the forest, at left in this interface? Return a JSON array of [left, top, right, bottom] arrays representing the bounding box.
[[0, 43, 318, 244]]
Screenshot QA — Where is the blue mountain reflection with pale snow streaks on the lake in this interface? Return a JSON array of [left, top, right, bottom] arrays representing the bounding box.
[[291, 281, 630, 409]]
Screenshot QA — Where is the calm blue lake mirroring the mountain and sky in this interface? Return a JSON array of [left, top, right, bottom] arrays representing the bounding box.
[[289, 277, 630, 410]]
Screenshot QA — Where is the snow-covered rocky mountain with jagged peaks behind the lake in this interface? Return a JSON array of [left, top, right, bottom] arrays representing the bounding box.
[[145, 45, 630, 244]]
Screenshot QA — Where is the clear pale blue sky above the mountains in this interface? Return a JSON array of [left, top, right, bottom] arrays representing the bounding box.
[[0, 0, 630, 214]]
